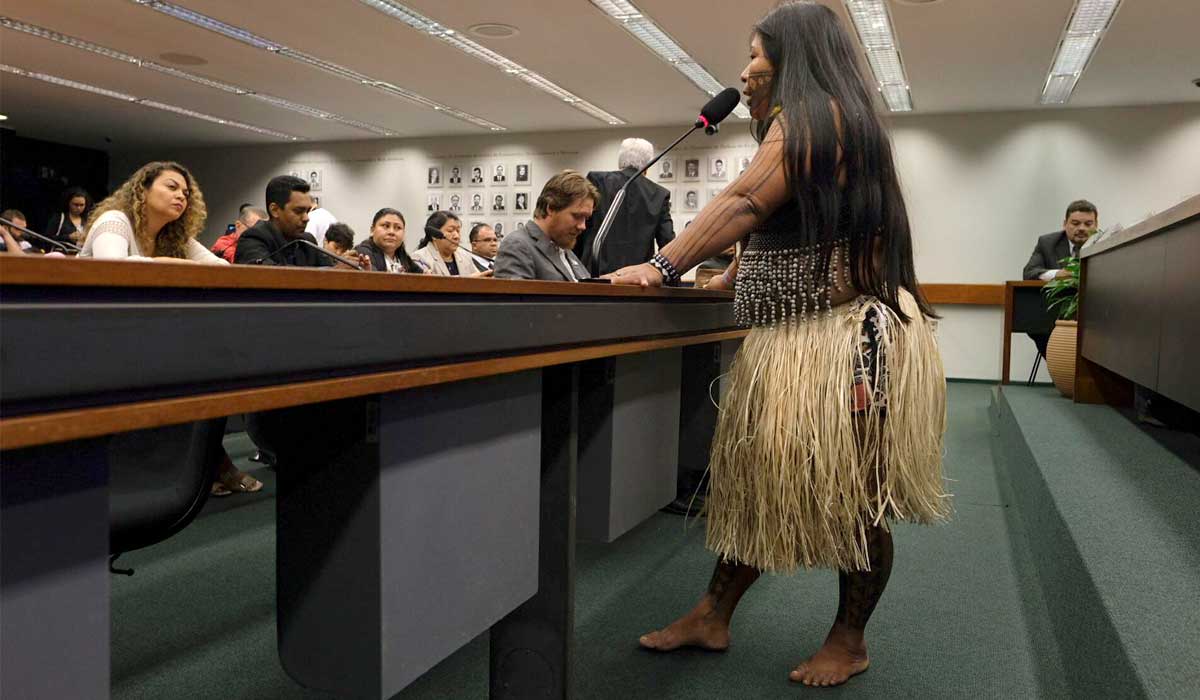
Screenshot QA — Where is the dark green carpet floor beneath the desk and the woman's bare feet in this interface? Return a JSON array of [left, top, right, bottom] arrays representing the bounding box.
[[113, 384, 1063, 700]]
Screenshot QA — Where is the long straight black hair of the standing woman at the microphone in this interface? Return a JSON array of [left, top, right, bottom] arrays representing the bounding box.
[[754, 1, 936, 319]]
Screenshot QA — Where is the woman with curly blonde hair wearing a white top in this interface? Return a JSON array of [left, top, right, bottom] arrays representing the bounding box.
[[79, 162, 229, 265]]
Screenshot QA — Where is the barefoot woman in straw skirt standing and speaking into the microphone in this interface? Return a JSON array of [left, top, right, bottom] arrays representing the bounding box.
[[611, 2, 949, 686]]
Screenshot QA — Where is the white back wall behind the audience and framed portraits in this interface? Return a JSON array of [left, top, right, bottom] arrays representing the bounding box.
[[112, 104, 1200, 379]]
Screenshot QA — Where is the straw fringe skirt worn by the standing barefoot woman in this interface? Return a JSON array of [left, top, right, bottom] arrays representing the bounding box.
[[706, 291, 949, 572]]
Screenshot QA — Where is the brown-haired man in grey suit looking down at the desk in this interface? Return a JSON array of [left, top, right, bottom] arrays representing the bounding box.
[[496, 170, 600, 282]]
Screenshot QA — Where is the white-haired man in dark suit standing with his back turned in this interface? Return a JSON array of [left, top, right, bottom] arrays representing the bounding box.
[[575, 138, 674, 276]]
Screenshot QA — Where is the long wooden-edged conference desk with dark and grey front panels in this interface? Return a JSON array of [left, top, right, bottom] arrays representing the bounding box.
[[0, 258, 744, 700]]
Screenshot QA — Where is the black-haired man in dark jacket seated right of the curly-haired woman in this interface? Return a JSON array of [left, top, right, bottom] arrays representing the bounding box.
[[235, 175, 371, 268]]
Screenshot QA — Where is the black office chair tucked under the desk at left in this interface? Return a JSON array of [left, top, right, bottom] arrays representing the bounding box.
[[108, 418, 226, 566]]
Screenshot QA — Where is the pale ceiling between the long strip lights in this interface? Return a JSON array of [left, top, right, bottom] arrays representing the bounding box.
[[0, 0, 1200, 149]]
